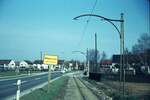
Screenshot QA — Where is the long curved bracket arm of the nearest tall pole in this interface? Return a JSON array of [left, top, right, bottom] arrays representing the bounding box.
[[73, 14, 124, 38]]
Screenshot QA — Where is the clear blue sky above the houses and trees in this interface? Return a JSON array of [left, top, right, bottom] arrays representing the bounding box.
[[0, 0, 150, 60]]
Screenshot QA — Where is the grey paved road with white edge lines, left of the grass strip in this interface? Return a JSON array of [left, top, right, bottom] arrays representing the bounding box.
[[0, 72, 62, 100]]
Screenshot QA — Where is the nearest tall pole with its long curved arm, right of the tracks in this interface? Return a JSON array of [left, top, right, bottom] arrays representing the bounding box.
[[73, 13, 125, 95]]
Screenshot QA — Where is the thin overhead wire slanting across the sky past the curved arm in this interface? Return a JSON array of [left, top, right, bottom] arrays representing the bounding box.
[[77, 0, 98, 47]]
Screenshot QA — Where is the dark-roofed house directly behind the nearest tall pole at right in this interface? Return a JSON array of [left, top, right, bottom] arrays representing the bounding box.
[[112, 53, 144, 75]]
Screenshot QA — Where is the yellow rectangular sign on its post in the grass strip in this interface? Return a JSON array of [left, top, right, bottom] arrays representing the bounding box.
[[44, 55, 58, 93]]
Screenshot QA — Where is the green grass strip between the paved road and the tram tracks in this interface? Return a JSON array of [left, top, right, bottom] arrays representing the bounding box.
[[21, 76, 69, 100]]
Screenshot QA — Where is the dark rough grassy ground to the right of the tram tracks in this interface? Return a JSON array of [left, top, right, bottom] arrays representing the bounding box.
[[83, 78, 150, 100]]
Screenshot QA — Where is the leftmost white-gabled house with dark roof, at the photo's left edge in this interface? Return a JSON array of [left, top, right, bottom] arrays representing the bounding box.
[[0, 60, 15, 70]]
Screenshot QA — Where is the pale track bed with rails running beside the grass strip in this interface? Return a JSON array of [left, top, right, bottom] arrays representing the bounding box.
[[63, 74, 99, 100]]
